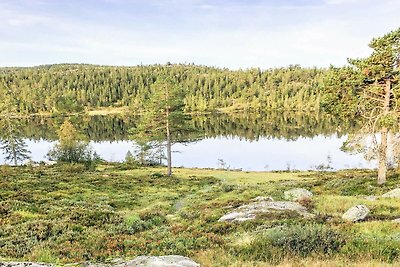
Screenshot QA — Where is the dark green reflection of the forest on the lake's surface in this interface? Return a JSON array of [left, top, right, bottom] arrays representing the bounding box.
[[0, 112, 360, 144]]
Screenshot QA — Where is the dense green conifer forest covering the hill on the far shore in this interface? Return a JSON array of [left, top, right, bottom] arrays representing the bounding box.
[[0, 64, 325, 114]]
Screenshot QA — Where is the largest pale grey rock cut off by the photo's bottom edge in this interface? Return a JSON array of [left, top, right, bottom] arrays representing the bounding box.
[[114, 255, 200, 267]]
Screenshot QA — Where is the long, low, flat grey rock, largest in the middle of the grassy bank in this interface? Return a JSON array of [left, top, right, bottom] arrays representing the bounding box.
[[218, 201, 313, 222]]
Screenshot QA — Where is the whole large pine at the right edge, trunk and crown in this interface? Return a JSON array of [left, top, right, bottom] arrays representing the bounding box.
[[322, 28, 400, 184]]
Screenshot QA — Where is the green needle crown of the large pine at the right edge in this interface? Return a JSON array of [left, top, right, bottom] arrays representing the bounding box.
[[321, 28, 400, 123]]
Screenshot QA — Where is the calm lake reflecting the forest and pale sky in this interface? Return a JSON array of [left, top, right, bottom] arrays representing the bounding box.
[[0, 112, 376, 171]]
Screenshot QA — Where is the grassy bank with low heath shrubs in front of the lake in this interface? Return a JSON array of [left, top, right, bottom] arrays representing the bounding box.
[[0, 164, 400, 266]]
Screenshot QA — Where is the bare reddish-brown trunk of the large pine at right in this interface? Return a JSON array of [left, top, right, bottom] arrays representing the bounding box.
[[378, 80, 392, 184]]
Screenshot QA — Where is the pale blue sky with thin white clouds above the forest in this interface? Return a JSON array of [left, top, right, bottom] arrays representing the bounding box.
[[0, 0, 400, 69]]
